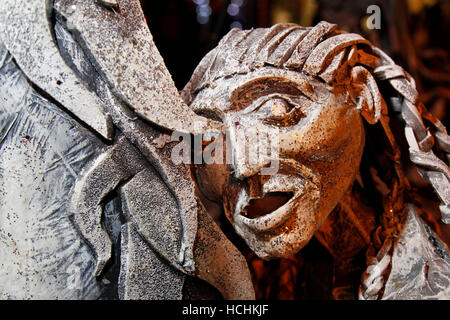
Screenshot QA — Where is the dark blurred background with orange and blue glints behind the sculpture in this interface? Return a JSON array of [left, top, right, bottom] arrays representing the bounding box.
[[141, 0, 450, 299]]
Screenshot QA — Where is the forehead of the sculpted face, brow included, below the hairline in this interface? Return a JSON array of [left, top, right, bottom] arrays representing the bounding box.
[[190, 67, 331, 116]]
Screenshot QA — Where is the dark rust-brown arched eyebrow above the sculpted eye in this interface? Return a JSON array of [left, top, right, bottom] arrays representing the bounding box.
[[229, 76, 314, 111]]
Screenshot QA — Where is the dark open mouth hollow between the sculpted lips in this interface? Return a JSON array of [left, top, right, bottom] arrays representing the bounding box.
[[241, 192, 294, 219]]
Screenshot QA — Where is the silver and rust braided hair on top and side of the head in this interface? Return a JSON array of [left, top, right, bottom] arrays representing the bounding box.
[[182, 22, 450, 228]]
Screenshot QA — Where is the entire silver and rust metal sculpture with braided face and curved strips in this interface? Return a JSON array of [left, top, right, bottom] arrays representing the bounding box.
[[0, 0, 450, 299]]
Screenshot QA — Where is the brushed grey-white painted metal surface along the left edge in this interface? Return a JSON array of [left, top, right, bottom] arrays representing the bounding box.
[[0, 44, 106, 299]]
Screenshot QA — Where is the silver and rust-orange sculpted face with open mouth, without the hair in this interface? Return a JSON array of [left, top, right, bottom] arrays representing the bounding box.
[[191, 67, 364, 259]]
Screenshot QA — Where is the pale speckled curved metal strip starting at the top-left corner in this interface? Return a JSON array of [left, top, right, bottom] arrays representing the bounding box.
[[0, 0, 113, 139]]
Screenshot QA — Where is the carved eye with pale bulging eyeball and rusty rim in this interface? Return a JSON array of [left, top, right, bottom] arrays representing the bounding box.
[[258, 98, 305, 127]]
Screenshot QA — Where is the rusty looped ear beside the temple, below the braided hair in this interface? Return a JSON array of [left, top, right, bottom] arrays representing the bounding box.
[[351, 66, 387, 124]]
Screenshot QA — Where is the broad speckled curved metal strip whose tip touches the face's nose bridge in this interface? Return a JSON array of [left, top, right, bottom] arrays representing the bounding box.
[[55, 0, 223, 133]]
